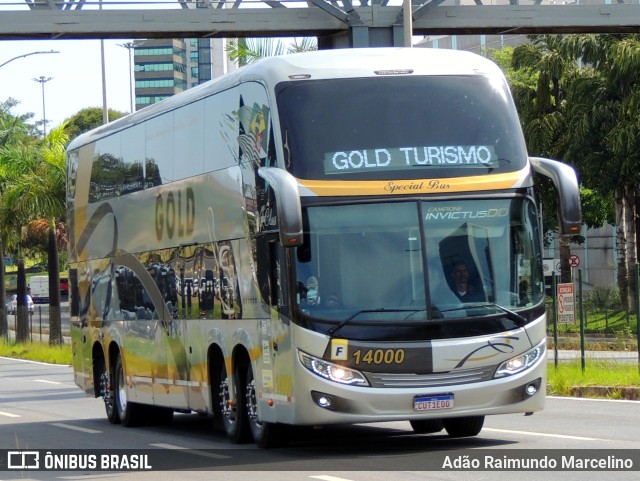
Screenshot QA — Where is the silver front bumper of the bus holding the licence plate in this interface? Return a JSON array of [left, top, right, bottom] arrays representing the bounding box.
[[294, 352, 546, 425]]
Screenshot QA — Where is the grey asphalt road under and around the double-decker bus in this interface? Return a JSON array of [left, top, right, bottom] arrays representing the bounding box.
[[0, 358, 640, 481]]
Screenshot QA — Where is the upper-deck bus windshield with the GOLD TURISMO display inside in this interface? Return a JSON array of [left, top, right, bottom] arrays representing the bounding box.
[[277, 76, 527, 180]]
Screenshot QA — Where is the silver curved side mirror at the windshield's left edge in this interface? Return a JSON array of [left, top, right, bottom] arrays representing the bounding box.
[[258, 167, 302, 247]]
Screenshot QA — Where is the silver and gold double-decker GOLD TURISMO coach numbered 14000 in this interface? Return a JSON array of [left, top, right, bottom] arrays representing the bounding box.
[[67, 48, 581, 447]]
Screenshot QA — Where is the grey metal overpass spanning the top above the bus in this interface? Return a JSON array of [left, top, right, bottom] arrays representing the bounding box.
[[0, 0, 640, 48]]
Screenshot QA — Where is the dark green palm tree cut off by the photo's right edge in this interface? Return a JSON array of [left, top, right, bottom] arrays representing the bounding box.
[[566, 35, 640, 309]]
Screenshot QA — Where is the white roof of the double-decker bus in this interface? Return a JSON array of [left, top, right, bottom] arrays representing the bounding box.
[[68, 48, 502, 150]]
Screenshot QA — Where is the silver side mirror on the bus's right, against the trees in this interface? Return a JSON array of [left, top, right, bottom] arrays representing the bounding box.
[[529, 157, 582, 235]]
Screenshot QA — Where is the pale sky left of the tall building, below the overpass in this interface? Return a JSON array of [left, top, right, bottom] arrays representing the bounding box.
[[0, 40, 131, 130]]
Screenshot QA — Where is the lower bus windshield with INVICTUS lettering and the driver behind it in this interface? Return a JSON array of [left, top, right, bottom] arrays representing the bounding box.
[[296, 197, 544, 335]]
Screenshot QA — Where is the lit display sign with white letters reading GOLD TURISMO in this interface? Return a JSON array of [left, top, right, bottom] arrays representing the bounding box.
[[324, 145, 498, 174]]
